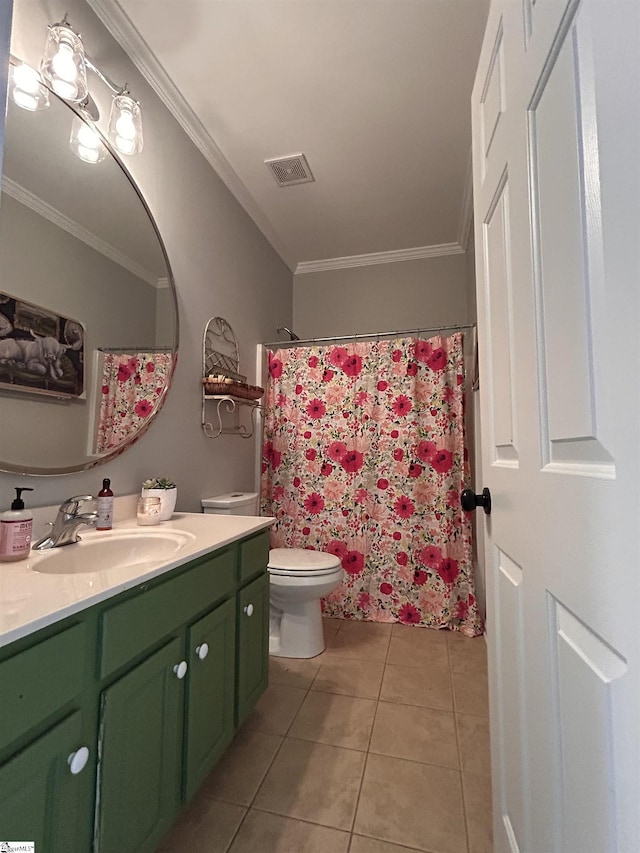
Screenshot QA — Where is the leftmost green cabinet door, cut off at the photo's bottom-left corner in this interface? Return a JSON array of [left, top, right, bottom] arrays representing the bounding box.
[[0, 712, 95, 853]]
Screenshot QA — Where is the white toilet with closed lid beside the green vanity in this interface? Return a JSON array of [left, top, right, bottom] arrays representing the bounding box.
[[202, 492, 344, 658]]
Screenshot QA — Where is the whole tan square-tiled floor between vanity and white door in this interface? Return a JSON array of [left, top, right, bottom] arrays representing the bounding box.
[[158, 619, 493, 853]]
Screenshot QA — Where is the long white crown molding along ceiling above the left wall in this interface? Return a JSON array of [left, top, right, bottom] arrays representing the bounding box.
[[87, 0, 295, 271]]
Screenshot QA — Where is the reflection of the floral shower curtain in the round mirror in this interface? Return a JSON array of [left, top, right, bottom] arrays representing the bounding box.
[[96, 352, 173, 453]]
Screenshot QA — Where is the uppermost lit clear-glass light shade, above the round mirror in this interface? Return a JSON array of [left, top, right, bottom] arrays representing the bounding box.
[[40, 24, 88, 103]]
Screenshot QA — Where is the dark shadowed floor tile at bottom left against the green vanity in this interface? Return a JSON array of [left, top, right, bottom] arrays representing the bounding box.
[[157, 795, 247, 853]]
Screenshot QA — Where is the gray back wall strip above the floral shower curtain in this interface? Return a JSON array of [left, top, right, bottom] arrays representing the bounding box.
[[293, 254, 470, 338]]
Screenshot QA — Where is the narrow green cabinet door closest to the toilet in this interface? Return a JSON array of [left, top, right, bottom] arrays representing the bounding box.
[[236, 572, 269, 725]]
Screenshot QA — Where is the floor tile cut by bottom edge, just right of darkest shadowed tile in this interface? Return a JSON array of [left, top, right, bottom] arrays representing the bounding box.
[[229, 809, 350, 853]]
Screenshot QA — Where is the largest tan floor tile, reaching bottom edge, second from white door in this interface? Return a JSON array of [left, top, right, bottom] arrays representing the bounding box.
[[354, 755, 467, 853]]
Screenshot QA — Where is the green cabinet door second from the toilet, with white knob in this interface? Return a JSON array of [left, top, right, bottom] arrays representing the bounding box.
[[184, 599, 236, 800]]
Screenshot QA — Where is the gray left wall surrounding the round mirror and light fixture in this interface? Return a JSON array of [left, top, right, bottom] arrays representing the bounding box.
[[0, 0, 292, 511]]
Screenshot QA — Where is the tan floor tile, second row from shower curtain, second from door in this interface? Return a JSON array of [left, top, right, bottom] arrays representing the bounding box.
[[380, 664, 453, 711]]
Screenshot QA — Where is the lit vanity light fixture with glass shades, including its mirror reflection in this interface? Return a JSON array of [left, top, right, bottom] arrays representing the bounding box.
[[11, 15, 144, 163]]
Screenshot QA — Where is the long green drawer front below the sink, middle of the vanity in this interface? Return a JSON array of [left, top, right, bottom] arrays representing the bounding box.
[[100, 548, 236, 678]]
